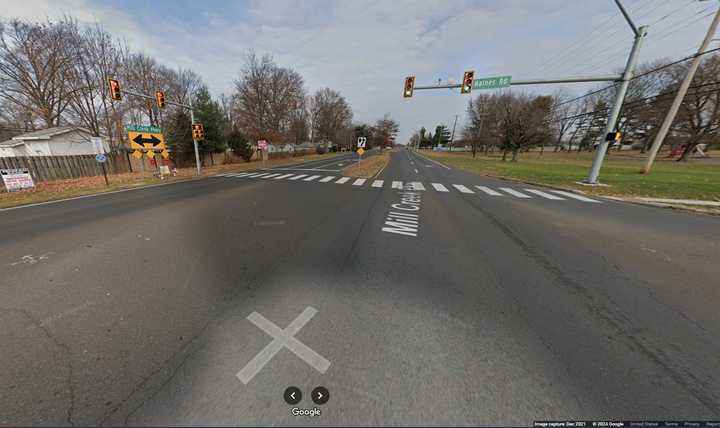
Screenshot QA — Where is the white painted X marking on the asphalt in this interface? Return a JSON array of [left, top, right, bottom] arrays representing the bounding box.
[[235, 306, 330, 385]]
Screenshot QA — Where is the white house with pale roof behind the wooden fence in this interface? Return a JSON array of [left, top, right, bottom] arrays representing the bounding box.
[[0, 126, 110, 157]]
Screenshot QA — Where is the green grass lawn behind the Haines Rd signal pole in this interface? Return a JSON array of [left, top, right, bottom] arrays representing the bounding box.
[[421, 150, 720, 201]]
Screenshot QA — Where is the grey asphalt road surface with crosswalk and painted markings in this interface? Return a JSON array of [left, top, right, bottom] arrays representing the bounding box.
[[0, 150, 720, 426]]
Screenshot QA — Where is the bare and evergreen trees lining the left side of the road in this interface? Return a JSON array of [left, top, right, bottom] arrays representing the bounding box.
[[0, 17, 397, 161]]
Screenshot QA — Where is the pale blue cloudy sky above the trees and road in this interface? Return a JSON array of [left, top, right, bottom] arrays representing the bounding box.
[[0, 0, 720, 143]]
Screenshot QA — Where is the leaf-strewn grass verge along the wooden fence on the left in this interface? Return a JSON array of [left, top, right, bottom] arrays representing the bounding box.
[[0, 153, 341, 208]]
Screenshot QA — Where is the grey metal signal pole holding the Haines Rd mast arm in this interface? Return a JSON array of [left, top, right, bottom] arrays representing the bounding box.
[[584, 0, 647, 185]]
